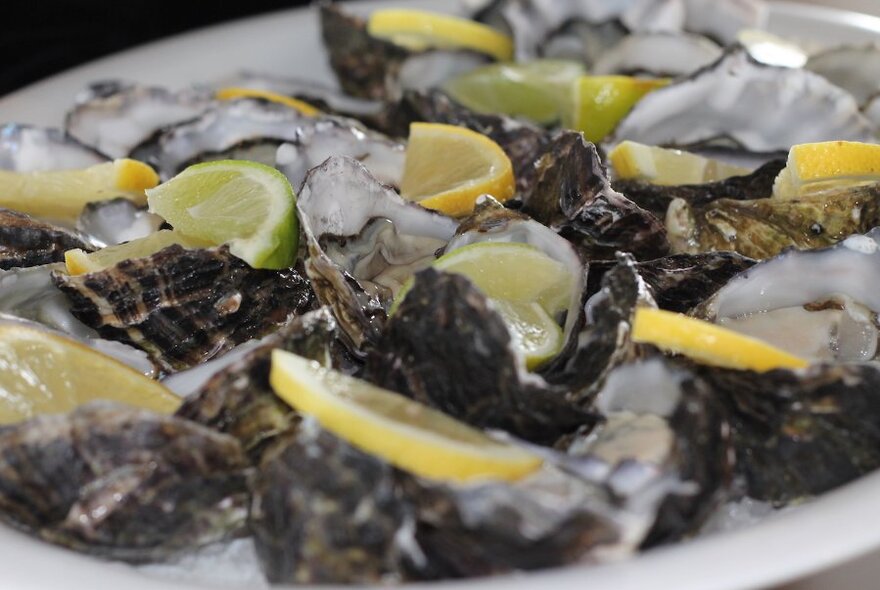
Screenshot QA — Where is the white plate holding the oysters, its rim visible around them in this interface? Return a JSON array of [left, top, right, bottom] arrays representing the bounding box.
[[0, 0, 880, 590]]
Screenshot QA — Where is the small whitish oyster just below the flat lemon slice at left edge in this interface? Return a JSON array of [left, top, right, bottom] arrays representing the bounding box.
[[76, 197, 165, 248]]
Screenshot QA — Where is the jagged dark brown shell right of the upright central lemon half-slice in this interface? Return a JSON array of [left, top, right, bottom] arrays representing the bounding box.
[[522, 131, 669, 260]]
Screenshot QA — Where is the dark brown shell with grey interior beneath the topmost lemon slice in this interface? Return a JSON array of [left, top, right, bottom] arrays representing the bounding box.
[[320, 3, 491, 101]]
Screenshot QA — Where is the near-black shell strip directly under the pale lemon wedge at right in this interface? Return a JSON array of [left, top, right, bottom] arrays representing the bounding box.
[[614, 159, 786, 219]]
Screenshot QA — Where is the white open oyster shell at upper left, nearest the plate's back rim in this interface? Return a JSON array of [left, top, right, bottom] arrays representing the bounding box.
[[65, 80, 211, 158]]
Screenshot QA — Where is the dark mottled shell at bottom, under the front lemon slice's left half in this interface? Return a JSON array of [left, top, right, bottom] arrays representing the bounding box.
[[250, 423, 412, 584]]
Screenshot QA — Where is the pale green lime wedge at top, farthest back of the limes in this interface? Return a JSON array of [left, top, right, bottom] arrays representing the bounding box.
[[444, 59, 586, 124]]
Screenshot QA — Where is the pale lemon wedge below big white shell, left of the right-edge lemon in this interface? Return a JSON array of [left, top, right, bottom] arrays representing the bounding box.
[[608, 140, 751, 186]]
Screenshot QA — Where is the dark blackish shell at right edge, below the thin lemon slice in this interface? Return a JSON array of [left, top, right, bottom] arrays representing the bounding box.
[[698, 364, 880, 504]]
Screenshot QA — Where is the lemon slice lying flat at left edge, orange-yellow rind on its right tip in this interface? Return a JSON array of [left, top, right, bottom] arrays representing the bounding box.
[[0, 159, 159, 221]]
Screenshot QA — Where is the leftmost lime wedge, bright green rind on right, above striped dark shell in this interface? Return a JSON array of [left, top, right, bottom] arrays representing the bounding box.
[[147, 160, 299, 269]]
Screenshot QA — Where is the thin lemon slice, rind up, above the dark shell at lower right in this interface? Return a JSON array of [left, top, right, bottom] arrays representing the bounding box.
[[632, 308, 809, 372]]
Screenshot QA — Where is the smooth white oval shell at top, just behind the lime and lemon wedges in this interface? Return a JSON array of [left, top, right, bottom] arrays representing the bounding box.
[[590, 33, 721, 77]]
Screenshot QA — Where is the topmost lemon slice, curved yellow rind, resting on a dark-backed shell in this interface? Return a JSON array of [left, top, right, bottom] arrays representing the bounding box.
[[367, 9, 513, 61]]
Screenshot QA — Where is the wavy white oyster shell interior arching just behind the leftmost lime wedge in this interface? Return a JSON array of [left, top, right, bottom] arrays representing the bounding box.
[[134, 99, 404, 187]]
